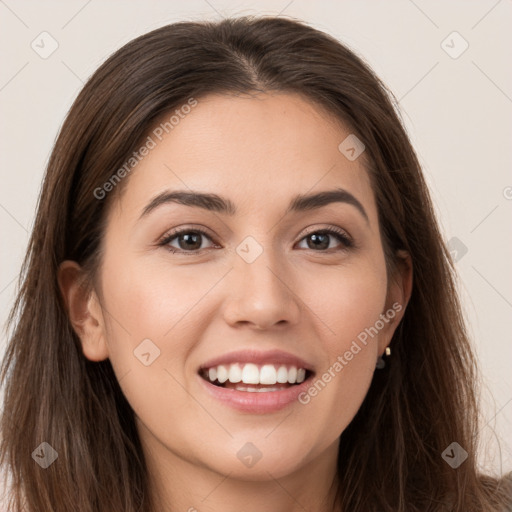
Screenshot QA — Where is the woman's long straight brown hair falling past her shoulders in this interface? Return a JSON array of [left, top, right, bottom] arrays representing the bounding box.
[[0, 17, 506, 512]]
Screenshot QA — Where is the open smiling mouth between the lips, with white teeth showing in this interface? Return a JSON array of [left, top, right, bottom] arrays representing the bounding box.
[[199, 362, 313, 393]]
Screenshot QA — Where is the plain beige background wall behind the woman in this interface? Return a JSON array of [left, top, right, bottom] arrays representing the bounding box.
[[0, 0, 512, 488]]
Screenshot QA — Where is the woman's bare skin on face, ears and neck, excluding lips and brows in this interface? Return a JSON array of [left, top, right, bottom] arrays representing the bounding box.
[[59, 93, 412, 512]]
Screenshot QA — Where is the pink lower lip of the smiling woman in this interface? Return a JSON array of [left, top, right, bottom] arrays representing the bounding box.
[[198, 376, 312, 414]]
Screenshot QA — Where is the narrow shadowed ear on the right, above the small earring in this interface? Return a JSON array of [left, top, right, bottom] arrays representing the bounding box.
[[379, 250, 413, 356]]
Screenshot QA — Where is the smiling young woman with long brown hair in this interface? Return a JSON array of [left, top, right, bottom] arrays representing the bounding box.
[[1, 17, 511, 512]]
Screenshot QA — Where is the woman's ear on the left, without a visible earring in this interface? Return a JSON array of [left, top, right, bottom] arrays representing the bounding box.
[[58, 260, 108, 361]]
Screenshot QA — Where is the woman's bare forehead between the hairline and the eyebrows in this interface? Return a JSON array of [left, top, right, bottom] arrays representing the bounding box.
[[113, 93, 375, 224]]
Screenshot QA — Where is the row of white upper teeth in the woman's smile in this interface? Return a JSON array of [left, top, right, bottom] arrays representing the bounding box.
[[207, 363, 306, 385]]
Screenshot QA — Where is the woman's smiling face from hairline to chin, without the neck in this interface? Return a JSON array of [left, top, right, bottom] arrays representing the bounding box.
[[66, 94, 404, 480]]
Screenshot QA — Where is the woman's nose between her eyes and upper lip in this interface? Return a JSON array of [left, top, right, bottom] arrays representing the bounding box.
[[224, 246, 301, 330]]
